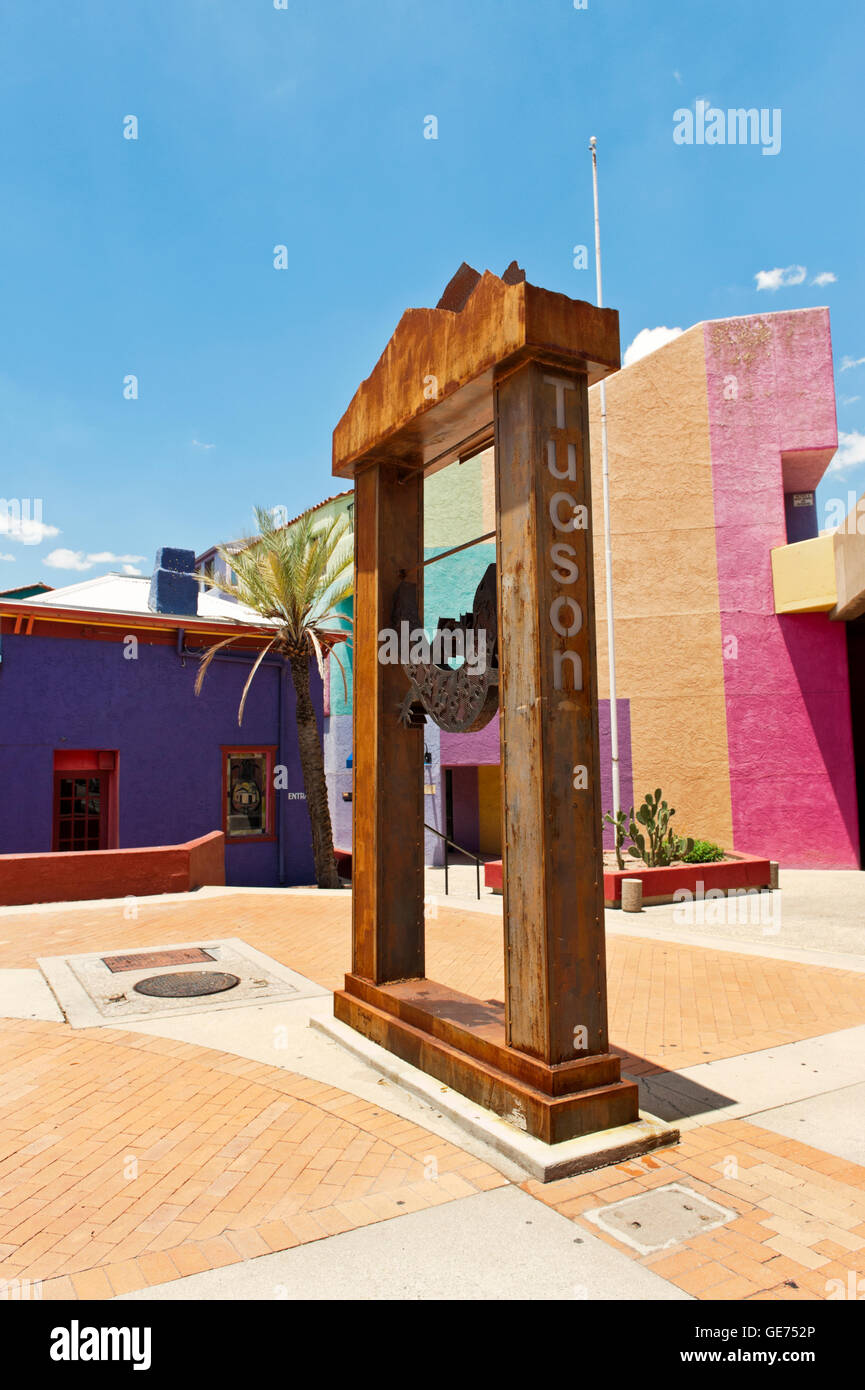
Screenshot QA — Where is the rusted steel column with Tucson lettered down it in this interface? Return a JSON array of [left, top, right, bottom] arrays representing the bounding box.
[[495, 361, 608, 1065]]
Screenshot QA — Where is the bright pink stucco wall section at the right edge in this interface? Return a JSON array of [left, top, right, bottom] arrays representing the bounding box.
[[704, 309, 859, 869]]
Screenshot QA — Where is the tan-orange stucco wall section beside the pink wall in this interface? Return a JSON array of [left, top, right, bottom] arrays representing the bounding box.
[[590, 325, 733, 845]]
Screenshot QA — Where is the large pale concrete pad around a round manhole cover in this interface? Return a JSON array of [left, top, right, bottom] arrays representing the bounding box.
[[39, 937, 328, 1029]]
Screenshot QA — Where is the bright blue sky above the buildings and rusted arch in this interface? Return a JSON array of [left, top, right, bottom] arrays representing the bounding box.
[[0, 0, 865, 588]]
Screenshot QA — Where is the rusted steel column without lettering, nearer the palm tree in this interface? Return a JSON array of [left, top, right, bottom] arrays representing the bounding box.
[[352, 463, 424, 984]]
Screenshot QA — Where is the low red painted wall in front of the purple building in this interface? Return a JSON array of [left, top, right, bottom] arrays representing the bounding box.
[[0, 830, 225, 906]]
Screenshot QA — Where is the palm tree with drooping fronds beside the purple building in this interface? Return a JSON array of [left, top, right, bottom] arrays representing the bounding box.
[[195, 507, 352, 888]]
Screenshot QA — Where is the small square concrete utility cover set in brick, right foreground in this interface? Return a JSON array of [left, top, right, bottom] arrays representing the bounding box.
[[583, 1183, 738, 1255]]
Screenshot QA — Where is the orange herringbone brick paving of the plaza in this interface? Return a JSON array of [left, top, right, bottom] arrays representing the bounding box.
[[0, 892, 865, 1300]]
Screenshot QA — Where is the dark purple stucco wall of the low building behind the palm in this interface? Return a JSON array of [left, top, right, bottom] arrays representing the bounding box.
[[0, 634, 321, 885]]
